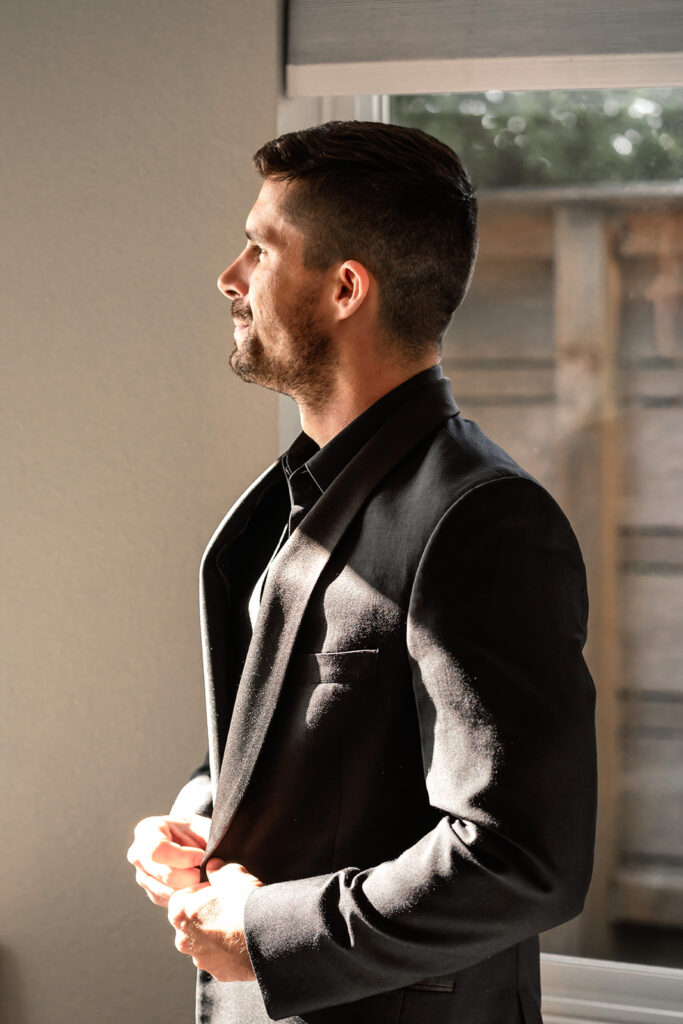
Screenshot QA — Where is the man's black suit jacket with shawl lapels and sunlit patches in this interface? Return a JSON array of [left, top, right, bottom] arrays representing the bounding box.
[[177, 381, 595, 1024]]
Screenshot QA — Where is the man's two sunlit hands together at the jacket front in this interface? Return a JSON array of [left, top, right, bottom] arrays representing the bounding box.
[[128, 815, 262, 981]]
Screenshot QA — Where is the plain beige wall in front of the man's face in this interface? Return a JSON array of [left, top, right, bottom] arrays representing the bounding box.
[[0, 0, 279, 1024]]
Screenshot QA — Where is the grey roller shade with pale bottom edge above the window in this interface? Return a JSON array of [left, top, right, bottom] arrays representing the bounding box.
[[286, 0, 683, 96]]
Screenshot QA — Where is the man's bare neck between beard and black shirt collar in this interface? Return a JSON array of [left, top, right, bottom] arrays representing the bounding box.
[[297, 354, 439, 447]]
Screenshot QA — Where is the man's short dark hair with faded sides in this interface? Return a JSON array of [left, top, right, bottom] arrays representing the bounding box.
[[254, 121, 477, 355]]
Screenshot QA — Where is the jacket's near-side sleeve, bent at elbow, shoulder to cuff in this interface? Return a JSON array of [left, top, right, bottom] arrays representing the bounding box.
[[246, 477, 595, 1019]]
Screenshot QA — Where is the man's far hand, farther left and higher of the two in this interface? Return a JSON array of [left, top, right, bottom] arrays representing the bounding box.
[[127, 814, 211, 906]]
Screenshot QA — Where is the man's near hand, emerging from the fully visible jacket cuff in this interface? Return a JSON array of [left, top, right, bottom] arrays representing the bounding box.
[[168, 858, 263, 981]]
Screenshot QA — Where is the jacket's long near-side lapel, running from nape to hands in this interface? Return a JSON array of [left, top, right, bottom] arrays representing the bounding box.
[[207, 380, 458, 859]]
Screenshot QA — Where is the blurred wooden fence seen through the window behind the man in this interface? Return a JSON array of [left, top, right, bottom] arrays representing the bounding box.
[[443, 184, 683, 958]]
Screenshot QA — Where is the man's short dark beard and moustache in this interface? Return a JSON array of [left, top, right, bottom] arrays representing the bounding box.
[[230, 301, 336, 408]]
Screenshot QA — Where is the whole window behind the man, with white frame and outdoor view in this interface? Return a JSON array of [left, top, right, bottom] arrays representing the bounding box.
[[280, 86, 683, 1024]]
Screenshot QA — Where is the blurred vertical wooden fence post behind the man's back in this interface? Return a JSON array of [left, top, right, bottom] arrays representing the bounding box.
[[545, 205, 621, 956]]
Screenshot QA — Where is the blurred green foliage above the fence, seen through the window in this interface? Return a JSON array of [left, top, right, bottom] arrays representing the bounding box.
[[391, 88, 683, 188]]
